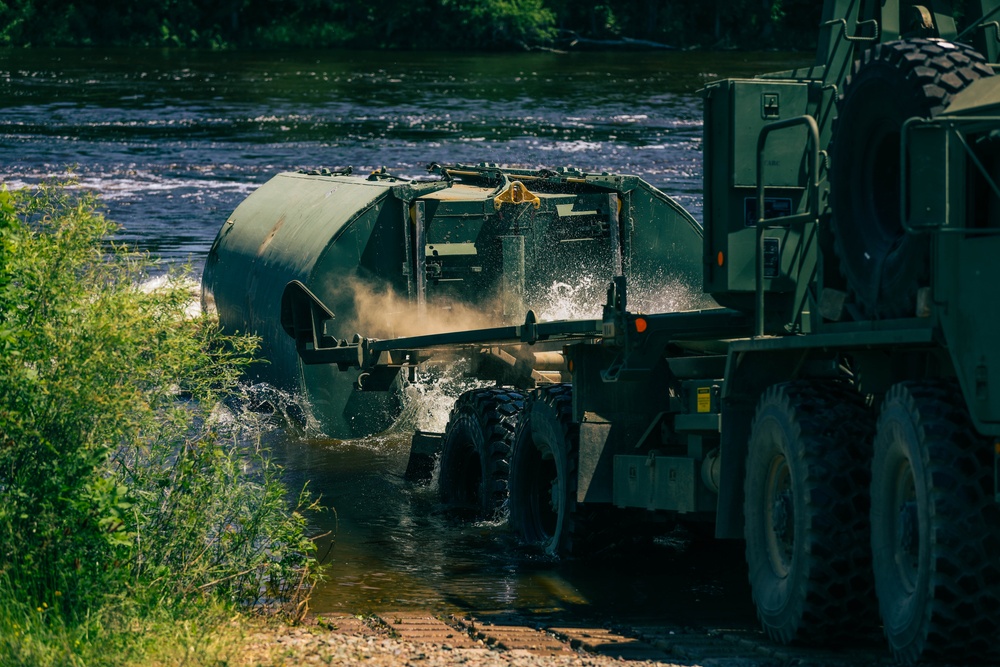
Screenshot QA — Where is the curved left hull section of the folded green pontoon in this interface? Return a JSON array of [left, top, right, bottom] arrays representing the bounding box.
[[203, 173, 399, 436]]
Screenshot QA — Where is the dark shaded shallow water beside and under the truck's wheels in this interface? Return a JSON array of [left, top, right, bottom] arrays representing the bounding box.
[[276, 426, 753, 626]]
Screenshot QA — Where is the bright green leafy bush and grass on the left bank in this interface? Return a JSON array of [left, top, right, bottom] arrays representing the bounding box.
[[0, 180, 315, 665]]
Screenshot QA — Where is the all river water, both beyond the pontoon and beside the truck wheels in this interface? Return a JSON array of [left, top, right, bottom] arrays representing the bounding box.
[[0, 45, 809, 622]]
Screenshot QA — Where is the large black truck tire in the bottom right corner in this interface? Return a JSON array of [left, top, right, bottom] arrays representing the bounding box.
[[871, 380, 1000, 663]]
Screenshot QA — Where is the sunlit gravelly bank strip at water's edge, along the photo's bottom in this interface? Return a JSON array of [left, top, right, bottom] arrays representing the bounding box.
[[229, 611, 893, 667]]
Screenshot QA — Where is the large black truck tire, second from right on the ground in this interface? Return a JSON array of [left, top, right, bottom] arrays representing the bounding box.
[[744, 381, 877, 644]]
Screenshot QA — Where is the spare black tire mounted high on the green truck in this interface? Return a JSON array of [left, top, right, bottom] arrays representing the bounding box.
[[830, 38, 993, 318]]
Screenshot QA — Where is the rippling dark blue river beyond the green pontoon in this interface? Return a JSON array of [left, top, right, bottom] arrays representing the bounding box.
[[0, 50, 803, 267]]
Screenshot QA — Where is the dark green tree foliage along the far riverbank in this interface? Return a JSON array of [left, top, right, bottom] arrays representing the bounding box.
[[0, 0, 822, 49]]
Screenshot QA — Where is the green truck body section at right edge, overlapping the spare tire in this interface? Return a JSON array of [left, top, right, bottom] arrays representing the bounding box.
[[903, 94, 1000, 435]]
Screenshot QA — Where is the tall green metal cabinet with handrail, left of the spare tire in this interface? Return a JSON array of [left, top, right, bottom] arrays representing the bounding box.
[[704, 79, 829, 326]]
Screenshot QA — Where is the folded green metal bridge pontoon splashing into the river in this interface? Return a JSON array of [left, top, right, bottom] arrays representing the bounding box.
[[202, 164, 701, 437]]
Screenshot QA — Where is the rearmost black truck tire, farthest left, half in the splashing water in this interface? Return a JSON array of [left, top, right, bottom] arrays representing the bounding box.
[[438, 388, 524, 519]]
